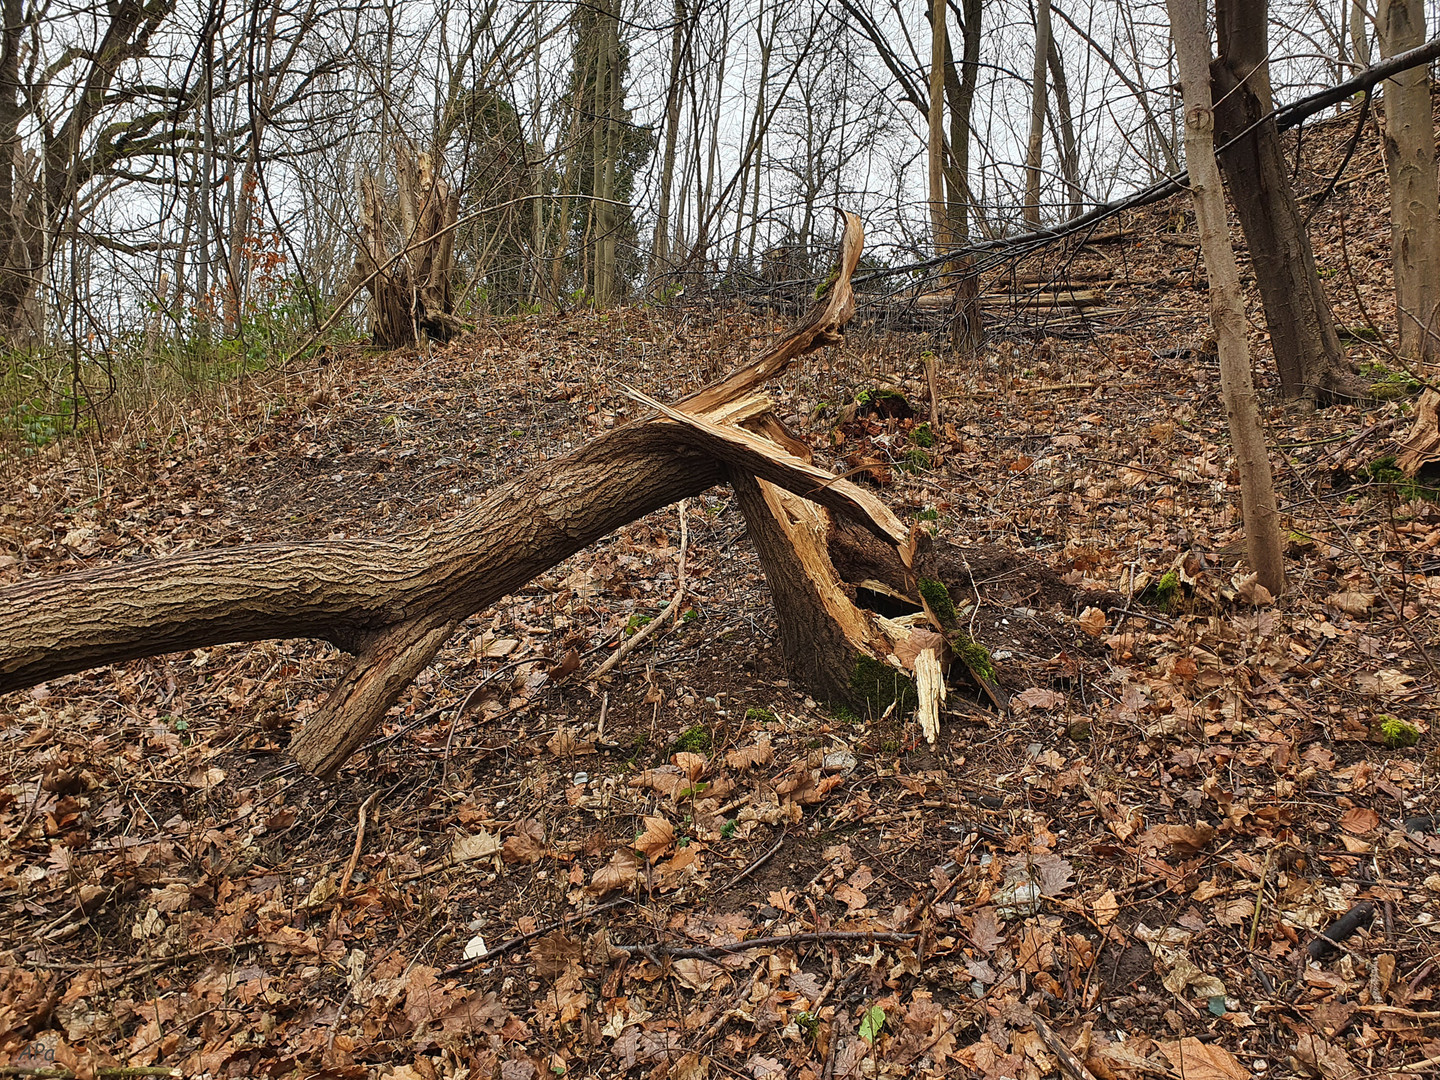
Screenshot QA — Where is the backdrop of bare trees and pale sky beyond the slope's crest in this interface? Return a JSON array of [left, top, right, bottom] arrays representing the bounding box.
[[0, 0, 1405, 444]]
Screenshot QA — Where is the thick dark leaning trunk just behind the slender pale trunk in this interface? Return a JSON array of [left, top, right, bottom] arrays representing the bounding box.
[[1210, 0, 1358, 399]]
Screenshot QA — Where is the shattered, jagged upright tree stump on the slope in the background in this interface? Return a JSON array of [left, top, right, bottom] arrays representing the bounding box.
[[344, 143, 465, 348]]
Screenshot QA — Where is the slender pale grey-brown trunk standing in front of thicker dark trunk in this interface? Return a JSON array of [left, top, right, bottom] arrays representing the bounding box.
[[1168, 0, 1284, 596]]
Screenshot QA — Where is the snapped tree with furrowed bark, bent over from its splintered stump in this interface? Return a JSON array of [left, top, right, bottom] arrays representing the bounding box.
[[0, 215, 979, 775]]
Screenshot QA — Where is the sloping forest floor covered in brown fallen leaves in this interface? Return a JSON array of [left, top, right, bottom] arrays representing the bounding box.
[[8, 105, 1440, 1080]]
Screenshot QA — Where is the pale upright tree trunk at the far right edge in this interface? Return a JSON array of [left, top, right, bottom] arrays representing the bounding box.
[[1377, 0, 1440, 477]]
